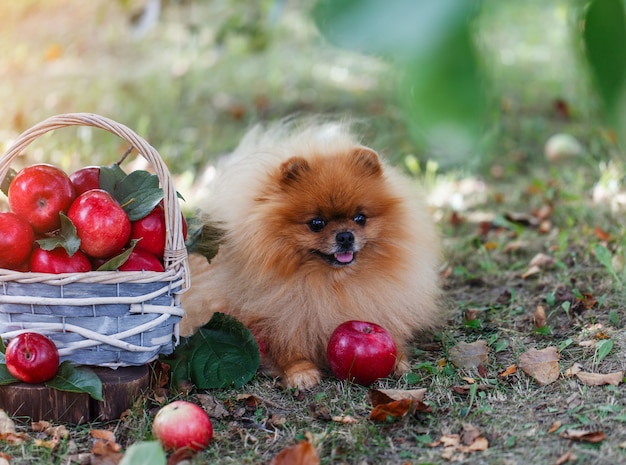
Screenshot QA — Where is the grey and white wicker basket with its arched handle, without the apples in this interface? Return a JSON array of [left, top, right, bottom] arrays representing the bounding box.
[[0, 113, 189, 367]]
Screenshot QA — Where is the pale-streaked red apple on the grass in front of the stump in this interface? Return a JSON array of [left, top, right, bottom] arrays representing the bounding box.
[[152, 400, 213, 451]]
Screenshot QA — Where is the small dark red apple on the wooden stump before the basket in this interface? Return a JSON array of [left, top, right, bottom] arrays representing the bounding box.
[[5, 332, 59, 384]]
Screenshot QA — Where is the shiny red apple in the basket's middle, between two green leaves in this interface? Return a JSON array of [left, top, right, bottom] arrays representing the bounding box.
[[67, 189, 130, 258]]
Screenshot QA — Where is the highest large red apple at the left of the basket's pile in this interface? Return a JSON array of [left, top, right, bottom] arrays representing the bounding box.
[[9, 163, 76, 233]]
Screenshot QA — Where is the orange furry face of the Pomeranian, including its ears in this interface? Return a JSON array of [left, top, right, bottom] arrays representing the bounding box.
[[257, 147, 396, 274]]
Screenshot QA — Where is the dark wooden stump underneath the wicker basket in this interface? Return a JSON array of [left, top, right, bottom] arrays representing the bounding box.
[[0, 365, 150, 424]]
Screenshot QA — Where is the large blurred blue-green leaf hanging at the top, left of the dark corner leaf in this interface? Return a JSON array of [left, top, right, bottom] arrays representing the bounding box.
[[313, 0, 489, 165]]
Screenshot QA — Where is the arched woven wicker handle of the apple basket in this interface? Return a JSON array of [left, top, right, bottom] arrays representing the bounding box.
[[0, 113, 189, 287]]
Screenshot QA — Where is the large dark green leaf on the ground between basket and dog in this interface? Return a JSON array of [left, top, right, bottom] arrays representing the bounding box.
[[162, 313, 261, 389]]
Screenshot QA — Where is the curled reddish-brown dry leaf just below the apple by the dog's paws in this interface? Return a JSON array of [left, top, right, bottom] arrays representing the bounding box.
[[369, 389, 431, 422]]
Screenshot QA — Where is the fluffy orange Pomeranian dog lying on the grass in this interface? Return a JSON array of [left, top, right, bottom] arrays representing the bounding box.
[[181, 120, 445, 389]]
